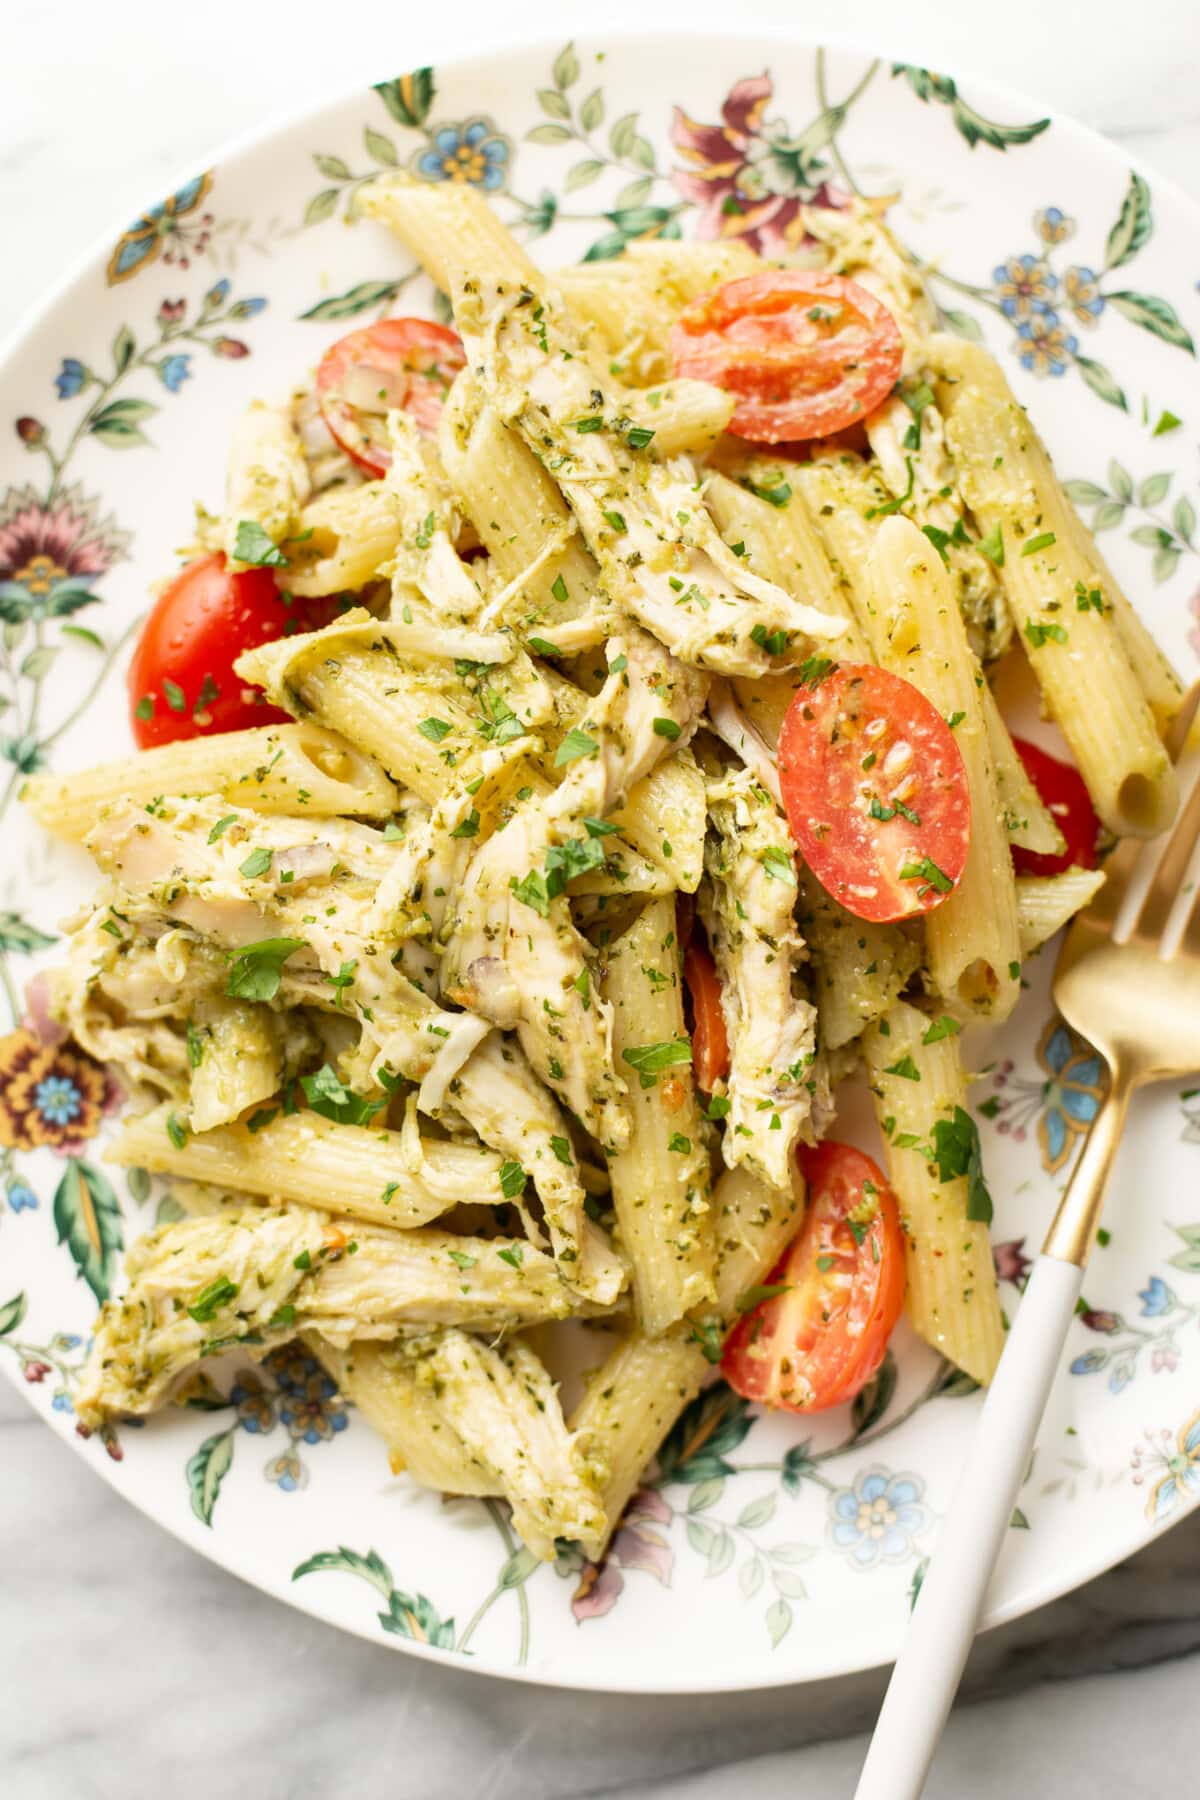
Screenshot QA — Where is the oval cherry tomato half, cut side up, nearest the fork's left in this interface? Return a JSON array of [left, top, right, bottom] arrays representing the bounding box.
[[779, 662, 972, 920]]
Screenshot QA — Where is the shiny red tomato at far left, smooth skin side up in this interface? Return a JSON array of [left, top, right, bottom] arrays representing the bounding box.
[[126, 554, 331, 751]]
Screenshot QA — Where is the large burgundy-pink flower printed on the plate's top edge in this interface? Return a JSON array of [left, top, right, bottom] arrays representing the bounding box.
[[671, 74, 846, 256]]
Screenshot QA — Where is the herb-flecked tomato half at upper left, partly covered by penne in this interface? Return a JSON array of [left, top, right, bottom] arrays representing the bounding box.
[[317, 319, 466, 475]]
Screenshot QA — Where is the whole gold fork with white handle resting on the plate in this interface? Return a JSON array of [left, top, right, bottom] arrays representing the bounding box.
[[856, 686, 1200, 1800]]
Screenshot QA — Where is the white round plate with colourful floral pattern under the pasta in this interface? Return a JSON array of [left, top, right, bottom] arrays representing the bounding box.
[[0, 38, 1200, 1690]]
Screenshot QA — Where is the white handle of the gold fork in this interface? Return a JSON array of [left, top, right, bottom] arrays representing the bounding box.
[[855, 1256, 1083, 1800]]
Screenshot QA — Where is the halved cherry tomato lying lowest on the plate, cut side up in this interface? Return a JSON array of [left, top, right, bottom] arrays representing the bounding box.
[[721, 1141, 905, 1413]]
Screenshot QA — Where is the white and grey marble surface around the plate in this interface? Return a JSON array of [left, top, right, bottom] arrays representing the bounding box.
[[0, 0, 1200, 1800]]
